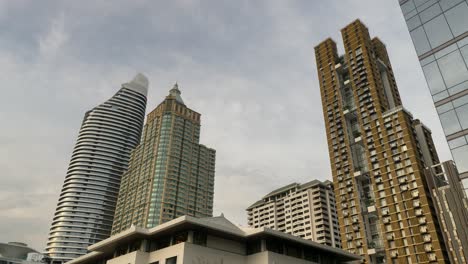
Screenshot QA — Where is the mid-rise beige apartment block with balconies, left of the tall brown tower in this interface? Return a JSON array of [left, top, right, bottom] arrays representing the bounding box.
[[247, 180, 341, 248]]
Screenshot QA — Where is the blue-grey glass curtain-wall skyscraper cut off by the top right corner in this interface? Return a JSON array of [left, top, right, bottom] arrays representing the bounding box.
[[399, 0, 468, 194]]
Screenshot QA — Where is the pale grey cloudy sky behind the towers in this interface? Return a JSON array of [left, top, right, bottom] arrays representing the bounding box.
[[0, 0, 450, 250]]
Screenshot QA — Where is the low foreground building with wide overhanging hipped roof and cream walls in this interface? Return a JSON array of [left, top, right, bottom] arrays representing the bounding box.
[[69, 216, 360, 264]]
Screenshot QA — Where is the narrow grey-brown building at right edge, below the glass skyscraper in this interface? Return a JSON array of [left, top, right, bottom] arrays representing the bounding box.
[[425, 161, 468, 264]]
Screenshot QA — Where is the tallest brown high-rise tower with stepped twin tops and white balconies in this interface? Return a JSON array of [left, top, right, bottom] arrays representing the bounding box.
[[315, 20, 448, 263]]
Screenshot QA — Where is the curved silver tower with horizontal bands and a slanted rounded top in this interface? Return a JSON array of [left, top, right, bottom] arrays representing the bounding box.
[[46, 74, 148, 263]]
